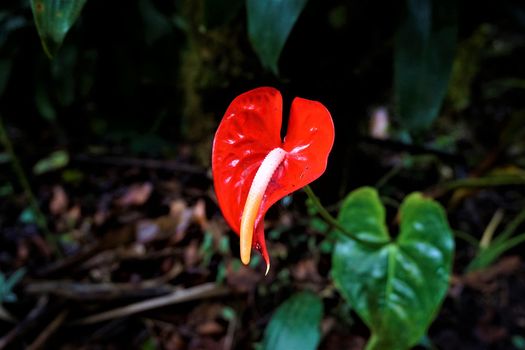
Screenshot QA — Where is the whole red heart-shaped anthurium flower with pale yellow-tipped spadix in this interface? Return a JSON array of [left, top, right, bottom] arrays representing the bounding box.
[[212, 87, 334, 273]]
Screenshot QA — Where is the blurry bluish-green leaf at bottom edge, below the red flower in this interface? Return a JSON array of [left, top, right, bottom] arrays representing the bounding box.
[[262, 292, 323, 350]]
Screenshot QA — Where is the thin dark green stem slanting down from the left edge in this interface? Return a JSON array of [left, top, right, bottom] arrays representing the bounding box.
[[0, 116, 60, 254]]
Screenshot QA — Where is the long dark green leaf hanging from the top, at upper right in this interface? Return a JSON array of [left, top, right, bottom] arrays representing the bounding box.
[[394, 0, 458, 131]]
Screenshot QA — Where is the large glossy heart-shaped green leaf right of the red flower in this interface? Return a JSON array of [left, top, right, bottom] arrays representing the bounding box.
[[332, 188, 454, 350]]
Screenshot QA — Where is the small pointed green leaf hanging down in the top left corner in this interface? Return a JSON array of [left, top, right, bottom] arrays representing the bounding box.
[[31, 0, 86, 58]]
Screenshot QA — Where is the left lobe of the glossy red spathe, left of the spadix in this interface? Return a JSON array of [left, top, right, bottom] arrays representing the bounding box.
[[212, 87, 282, 235]]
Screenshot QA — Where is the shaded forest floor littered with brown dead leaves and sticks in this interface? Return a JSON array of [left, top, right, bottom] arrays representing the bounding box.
[[0, 135, 525, 350]]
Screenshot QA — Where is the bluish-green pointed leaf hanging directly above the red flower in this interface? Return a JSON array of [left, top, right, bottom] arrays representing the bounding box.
[[246, 0, 307, 75]]
